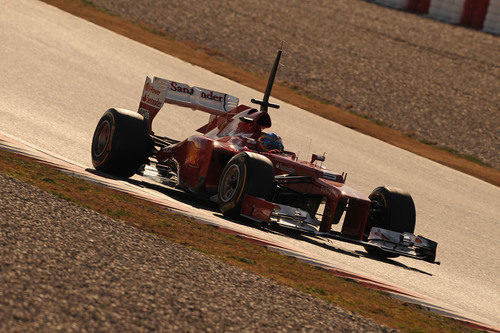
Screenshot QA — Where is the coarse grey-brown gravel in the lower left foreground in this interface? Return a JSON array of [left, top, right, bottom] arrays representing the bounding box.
[[0, 174, 394, 332]]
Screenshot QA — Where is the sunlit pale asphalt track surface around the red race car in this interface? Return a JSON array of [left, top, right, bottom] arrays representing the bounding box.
[[0, 0, 500, 327]]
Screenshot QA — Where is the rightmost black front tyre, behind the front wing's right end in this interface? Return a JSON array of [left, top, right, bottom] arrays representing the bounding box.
[[364, 186, 416, 258]]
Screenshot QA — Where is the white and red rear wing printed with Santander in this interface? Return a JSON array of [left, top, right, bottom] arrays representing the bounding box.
[[138, 77, 239, 129]]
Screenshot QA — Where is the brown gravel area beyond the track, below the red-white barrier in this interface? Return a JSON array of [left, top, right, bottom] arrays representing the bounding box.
[[92, 0, 500, 169]]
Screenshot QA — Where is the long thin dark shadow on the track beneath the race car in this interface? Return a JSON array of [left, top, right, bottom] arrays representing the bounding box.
[[86, 169, 433, 276]]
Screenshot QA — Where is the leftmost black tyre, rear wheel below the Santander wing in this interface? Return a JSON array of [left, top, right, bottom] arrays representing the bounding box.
[[91, 109, 151, 178]]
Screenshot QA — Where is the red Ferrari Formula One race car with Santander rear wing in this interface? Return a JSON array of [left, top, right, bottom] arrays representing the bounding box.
[[91, 49, 437, 263]]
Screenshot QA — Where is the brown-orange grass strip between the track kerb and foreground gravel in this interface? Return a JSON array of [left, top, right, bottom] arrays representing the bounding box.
[[0, 150, 474, 332]]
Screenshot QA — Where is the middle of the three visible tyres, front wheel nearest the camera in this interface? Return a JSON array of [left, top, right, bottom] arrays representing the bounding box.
[[217, 152, 276, 217]]
